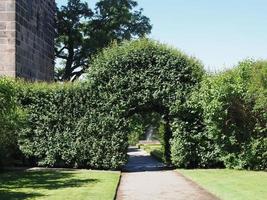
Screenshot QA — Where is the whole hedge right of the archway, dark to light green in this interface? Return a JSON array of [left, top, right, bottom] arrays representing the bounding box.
[[172, 61, 267, 169]]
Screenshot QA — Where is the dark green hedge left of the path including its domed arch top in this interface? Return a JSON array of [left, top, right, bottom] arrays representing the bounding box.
[[16, 39, 204, 169]]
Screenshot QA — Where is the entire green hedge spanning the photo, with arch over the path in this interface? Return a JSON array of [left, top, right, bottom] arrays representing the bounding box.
[[0, 39, 267, 170]]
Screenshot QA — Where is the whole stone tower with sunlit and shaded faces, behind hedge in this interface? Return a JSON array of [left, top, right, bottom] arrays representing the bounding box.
[[0, 0, 56, 81]]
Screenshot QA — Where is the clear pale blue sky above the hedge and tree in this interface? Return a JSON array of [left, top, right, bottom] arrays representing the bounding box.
[[56, 0, 267, 72]]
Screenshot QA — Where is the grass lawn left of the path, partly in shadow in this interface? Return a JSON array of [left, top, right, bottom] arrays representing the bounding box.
[[0, 170, 120, 200]]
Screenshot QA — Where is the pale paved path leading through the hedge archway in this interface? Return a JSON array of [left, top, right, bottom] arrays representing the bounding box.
[[117, 148, 217, 200]]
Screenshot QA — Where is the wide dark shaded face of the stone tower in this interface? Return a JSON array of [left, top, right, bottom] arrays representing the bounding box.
[[16, 0, 55, 80]]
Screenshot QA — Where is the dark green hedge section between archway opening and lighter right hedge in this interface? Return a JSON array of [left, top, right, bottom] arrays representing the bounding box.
[[171, 88, 223, 168]]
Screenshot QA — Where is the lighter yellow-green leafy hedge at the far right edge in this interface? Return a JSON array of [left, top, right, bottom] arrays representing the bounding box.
[[200, 61, 267, 169]]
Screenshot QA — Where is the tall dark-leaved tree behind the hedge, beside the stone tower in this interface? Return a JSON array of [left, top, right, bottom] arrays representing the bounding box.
[[55, 0, 152, 81]]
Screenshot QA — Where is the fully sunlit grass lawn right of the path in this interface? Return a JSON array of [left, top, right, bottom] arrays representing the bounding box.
[[178, 169, 267, 200]]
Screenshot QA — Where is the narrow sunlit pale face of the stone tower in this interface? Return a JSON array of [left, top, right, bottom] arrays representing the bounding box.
[[0, 0, 16, 77]]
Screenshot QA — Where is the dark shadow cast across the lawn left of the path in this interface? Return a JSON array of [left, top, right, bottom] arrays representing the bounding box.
[[0, 171, 98, 200]]
